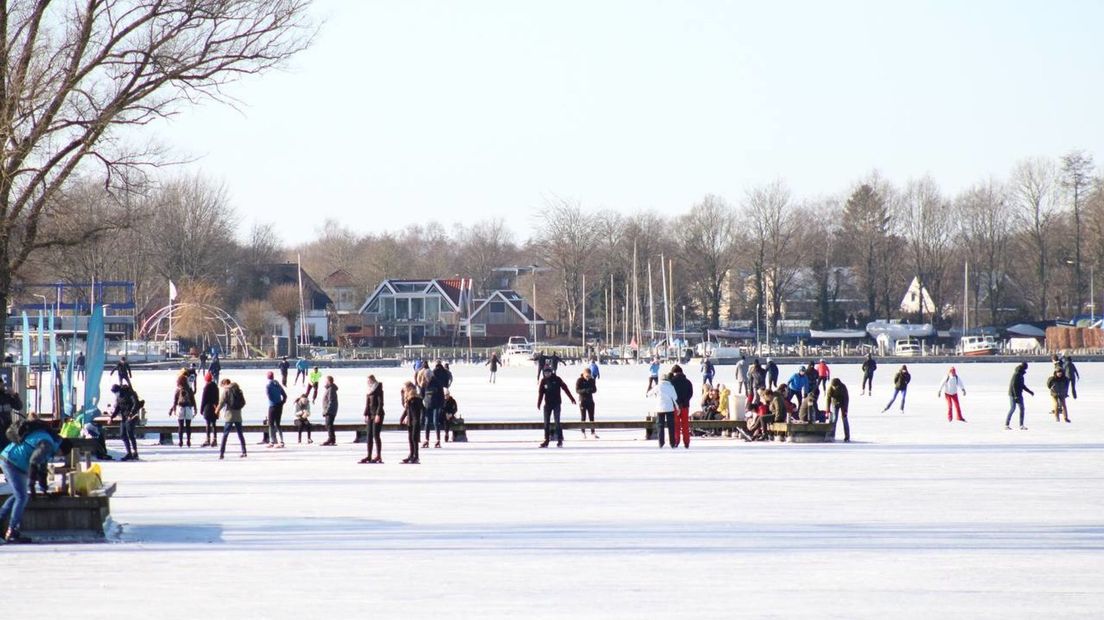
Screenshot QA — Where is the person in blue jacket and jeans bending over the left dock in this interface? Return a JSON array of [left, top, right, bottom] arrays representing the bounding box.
[[0, 421, 73, 543]]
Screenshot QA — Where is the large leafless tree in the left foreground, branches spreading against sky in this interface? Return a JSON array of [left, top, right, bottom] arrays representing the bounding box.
[[0, 0, 311, 348]]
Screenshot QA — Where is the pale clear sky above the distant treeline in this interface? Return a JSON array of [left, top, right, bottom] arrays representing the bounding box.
[[155, 0, 1104, 244]]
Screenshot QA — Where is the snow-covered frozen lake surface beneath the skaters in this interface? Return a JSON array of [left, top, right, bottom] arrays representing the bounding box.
[[0, 362, 1104, 618]]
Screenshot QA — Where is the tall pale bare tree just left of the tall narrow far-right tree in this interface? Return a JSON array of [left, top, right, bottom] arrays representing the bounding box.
[[1010, 159, 1058, 318]]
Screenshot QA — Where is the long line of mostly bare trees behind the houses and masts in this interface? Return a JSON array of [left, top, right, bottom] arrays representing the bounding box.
[[22, 151, 1104, 334]]
